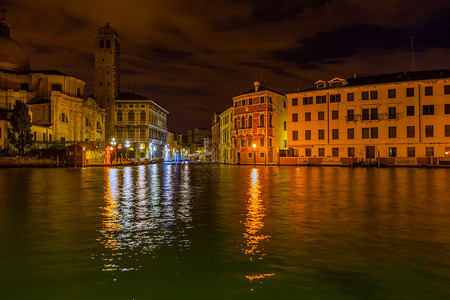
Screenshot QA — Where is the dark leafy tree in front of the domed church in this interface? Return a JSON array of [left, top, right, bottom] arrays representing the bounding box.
[[8, 100, 33, 154]]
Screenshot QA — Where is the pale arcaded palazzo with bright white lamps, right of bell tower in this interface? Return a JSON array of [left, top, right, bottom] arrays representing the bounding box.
[[110, 92, 170, 159]]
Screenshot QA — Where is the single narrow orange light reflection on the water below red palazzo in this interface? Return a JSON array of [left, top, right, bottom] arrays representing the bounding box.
[[243, 168, 274, 290]]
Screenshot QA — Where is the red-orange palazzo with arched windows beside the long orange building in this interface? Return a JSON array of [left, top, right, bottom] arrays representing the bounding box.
[[232, 82, 286, 164]]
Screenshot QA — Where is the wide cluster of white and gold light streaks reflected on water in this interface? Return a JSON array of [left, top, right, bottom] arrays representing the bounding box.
[[94, 165, 193, 271]]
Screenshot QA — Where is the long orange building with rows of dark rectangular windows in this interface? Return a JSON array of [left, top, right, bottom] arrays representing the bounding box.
[[287, 70, 450, 164]]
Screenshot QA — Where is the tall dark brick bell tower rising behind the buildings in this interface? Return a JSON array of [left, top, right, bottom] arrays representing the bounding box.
[[94, 23, 120, 142]]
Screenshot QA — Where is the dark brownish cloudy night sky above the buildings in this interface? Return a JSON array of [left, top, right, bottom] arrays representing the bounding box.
[[0, 0, 450, 132]]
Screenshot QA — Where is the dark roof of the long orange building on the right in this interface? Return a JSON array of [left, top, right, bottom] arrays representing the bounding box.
[[292, 70, 450, 93]]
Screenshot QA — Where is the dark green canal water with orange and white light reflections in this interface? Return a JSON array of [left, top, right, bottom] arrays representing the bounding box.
[[0, 164, 450, 299]]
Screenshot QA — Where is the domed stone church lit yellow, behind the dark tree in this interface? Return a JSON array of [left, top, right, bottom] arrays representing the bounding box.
[[0, 17, 105, 148]]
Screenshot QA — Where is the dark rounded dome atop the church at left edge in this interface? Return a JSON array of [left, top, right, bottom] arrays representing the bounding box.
[[0, 17, 30, 72]]
